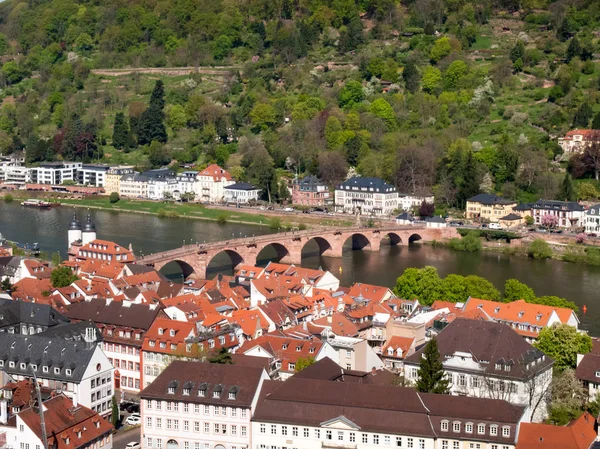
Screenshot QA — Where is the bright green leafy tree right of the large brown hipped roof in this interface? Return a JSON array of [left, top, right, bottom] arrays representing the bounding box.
[[534, 324, 592, 371]]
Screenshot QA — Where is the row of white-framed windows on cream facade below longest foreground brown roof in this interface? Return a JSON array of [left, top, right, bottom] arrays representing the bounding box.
[[259, 424, 425, 449]]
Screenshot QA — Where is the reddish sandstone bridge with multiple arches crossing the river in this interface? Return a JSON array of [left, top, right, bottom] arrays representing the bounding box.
[[136, 226, 459, 279]]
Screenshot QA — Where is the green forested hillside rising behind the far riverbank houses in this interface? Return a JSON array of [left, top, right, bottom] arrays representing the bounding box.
[[0, 0, 600, 207]]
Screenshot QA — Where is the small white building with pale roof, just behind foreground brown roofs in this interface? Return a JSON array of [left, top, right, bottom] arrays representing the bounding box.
[[315, 329, 383, 371]]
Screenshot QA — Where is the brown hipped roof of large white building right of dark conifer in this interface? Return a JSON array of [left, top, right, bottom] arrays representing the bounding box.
[[404, 318, 554, 380]]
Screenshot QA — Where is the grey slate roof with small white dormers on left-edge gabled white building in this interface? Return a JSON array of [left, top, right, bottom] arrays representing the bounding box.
[[0, 333, 102, 382]]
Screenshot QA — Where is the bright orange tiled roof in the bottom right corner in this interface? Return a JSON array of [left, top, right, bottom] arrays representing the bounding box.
[[516, 412, 596, 449]]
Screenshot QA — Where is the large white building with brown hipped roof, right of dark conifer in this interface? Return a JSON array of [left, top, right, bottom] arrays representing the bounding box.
[[404, 318, 554, 422]]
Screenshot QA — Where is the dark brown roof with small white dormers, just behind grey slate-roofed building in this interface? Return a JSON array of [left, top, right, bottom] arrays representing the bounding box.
[[64, 299, 161, 330]]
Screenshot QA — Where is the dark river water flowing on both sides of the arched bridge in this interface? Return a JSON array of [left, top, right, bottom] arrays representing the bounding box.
[[0, 202, 600, 335]]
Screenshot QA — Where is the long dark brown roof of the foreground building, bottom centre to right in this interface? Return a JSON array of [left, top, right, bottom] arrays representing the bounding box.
[[253, 374, 524, 444]]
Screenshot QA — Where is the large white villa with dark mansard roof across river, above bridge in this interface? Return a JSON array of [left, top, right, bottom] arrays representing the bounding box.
[[335, 176, 399, 215]]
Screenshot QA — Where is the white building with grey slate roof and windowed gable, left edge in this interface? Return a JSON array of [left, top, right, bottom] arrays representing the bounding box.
[[0, 327, 114, 417]]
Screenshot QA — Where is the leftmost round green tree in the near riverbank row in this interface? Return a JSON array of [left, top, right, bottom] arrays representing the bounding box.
[[394, 266, 442, 306]]
